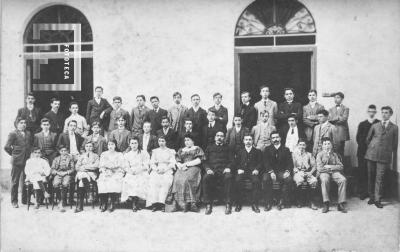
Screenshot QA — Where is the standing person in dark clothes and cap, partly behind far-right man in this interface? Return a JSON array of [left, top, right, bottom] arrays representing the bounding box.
[[356, 104, 379, 200]]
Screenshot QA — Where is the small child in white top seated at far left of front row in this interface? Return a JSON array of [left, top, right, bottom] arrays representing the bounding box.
[[25, 147, 50, 209]]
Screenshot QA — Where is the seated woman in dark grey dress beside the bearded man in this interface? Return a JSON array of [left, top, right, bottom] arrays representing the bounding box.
[[172, 134, 204, 212]]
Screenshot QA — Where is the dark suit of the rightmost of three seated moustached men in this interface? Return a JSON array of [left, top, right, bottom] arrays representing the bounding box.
[[262, 144, 293, 203]]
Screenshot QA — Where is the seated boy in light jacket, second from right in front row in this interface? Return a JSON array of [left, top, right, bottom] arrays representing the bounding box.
[[292, 138, 318, 210]]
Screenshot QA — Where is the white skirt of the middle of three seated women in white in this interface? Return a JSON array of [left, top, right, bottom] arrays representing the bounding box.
[[121, 171, 149, 201]]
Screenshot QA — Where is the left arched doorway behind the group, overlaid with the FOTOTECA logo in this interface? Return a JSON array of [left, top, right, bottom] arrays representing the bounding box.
[[23, 5, 93, 113]]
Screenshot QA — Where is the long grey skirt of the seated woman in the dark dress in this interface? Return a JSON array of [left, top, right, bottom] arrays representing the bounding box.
[[172, 166, 201, 208]]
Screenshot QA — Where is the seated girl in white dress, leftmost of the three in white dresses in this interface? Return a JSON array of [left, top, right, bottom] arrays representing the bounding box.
[[97, 140, 125, 212]]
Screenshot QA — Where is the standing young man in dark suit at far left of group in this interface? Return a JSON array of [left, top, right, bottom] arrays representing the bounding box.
[[4, 117, 32, 208]]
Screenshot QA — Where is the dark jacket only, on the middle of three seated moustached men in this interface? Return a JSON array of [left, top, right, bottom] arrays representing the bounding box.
[[235, 147, 263, 175]]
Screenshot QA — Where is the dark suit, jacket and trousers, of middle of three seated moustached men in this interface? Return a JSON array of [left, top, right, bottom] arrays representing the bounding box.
[[235, 147, 262, 205]]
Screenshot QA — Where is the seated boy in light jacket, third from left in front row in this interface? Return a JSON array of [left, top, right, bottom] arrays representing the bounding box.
[[75, 142, 100, 213]]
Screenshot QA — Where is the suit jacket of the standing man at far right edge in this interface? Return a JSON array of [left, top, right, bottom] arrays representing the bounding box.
[[365, 122, 399, 163]]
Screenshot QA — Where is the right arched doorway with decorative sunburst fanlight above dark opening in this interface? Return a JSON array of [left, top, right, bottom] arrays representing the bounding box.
[[234, 0, 316, 110]]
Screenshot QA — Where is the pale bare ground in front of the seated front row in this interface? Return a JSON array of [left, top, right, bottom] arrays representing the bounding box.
[[1, 193, 400, 252]]
